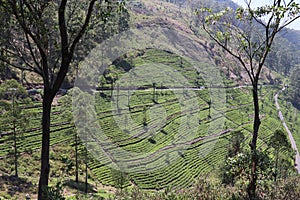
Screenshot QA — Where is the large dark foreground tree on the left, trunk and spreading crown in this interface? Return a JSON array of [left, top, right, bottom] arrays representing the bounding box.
[[0, 0, 123, 199]]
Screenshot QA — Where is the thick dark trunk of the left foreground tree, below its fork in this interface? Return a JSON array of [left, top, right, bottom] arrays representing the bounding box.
[[38, 90, 53, 200]]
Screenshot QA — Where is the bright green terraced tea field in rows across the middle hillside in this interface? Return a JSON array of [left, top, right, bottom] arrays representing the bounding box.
[[0, 50, 300, 189]]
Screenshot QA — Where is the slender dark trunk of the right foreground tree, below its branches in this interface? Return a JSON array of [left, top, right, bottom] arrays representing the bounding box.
[[248, 82, 261, 200]]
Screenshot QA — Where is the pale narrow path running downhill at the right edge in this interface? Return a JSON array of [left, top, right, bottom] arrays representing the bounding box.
[[274, 87, 300, 174]]
